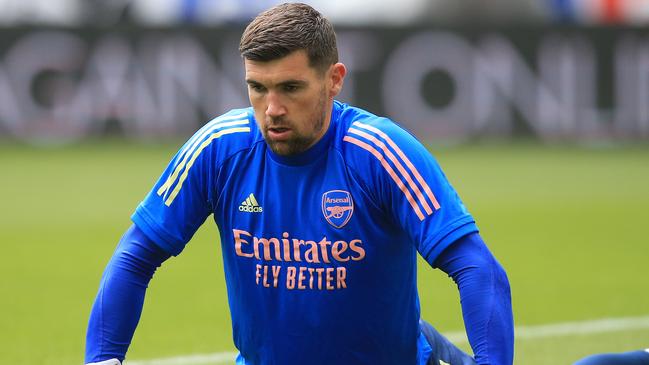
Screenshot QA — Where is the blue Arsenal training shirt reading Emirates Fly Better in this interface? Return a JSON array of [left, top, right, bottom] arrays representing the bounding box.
[[121, 102, 486, 365]]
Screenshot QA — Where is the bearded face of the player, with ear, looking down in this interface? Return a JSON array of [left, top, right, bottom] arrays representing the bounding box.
[[244, 51, 345, 156]]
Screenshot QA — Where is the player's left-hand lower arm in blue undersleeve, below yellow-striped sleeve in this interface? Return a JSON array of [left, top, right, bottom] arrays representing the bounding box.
[[85, 225, 170, 363]]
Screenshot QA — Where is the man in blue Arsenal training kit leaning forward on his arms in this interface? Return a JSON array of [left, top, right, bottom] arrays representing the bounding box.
[[86, 4, 513, 365]]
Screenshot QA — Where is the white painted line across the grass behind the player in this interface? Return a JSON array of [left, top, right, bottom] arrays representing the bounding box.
[[125, 316, 649, 365]]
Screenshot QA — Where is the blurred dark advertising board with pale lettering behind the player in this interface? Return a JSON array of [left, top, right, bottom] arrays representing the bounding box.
[[0, 27, 649, 143]]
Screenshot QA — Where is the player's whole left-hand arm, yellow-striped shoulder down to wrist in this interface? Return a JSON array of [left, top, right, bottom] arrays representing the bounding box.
[[86, 109, 254, 365]]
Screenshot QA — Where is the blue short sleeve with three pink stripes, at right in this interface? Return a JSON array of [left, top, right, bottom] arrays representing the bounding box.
[[344, 119, 478, 265]]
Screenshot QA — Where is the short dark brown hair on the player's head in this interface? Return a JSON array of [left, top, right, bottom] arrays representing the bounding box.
[[239, 3, 338, 71]]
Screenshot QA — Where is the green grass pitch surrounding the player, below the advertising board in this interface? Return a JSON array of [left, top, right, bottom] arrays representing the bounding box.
[[0, 142, 649, 365]]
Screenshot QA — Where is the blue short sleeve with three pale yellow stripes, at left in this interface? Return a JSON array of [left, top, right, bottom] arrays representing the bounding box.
[[131, 110, 250, 255]]
